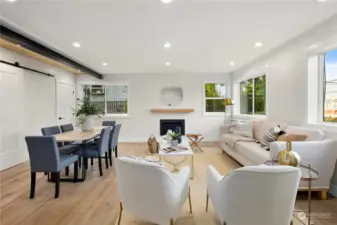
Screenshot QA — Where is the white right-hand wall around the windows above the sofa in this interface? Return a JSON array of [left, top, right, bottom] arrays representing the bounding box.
[[232, 16, 337, 196]]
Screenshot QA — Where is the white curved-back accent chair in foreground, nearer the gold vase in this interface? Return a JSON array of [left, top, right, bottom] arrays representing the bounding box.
[[206, 165, 301, 225]]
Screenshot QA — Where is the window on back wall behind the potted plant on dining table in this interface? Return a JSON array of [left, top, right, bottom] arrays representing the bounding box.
[[84, 85, 128, 114]]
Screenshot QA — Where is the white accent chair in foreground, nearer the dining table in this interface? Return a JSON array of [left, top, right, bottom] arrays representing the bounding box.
[[116, 157, 192, 225]]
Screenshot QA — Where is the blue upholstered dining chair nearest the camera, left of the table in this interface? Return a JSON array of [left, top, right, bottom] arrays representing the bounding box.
[[25, 136, 78, 198]]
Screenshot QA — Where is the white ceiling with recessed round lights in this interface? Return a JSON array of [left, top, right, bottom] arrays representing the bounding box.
[[0, 0, 337, 74]]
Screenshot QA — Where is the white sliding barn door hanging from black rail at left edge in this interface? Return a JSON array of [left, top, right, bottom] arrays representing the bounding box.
[[0, 63, 25, 171]]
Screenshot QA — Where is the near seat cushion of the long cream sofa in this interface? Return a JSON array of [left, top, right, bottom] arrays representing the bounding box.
[[235, 142, 270, 165]]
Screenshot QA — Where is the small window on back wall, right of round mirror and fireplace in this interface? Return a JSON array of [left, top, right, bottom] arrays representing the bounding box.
[[205, 83, 226, 113]]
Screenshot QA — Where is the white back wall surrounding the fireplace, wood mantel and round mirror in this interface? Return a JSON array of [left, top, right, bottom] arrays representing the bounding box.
[[77, 74, 230, 142]]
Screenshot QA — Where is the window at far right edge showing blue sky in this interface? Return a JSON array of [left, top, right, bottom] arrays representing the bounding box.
[[324, 49, 337, 123]]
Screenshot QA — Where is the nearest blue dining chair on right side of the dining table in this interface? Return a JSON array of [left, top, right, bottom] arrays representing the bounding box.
[[75, 127, 111, 176]]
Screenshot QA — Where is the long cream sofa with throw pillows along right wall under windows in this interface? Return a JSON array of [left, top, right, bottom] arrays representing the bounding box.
[[220, 119, 337, 199]]
